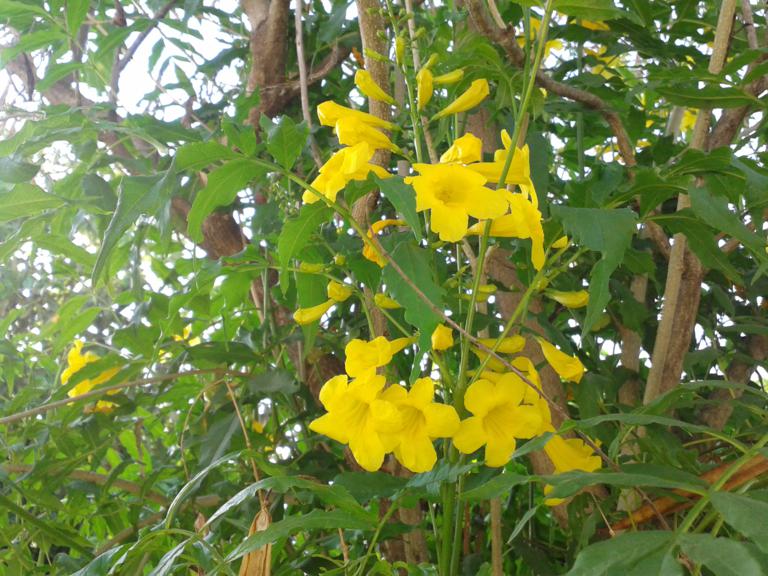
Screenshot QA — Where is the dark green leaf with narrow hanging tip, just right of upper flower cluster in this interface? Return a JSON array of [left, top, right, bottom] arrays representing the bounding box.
[[552, 206, 637, 334]]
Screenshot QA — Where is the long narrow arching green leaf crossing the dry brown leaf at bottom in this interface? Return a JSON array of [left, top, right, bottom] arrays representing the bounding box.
[[225, 510, 376, 563]]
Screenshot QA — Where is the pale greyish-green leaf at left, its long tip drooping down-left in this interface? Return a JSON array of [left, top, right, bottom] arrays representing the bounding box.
[[91, 166, 174, 285]]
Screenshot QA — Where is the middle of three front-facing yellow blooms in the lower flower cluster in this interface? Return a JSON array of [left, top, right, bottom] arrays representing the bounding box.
[[380, 378, 459, 474]]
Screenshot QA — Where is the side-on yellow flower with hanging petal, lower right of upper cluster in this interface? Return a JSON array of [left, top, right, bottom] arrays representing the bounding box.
[[467, 193, 545, 270]]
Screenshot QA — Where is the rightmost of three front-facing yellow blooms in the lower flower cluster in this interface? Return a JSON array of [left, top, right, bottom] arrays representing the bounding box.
[[453, 373, 542, 467]]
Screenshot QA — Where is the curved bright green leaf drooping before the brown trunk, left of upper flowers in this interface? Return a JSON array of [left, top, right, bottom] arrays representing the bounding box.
[[187, 159, 265, 242]]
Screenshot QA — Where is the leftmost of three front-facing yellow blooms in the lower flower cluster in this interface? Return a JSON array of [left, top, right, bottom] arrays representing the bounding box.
[[309, 374, 402, 472]]
